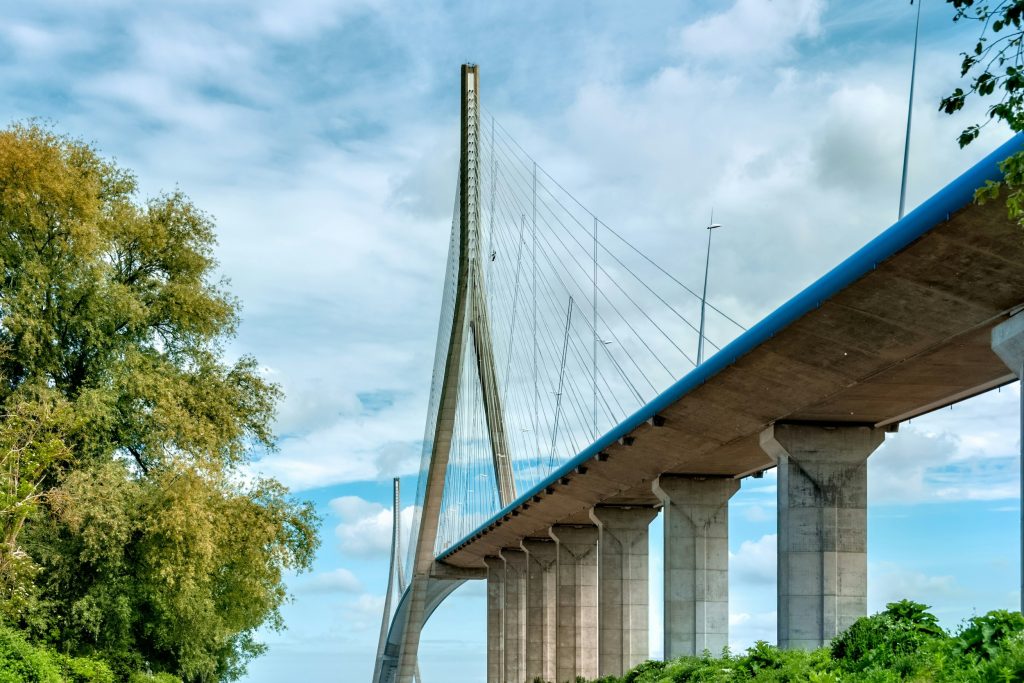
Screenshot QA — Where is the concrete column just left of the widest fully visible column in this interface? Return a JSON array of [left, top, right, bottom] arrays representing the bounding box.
[[652, 474, 739, 659]]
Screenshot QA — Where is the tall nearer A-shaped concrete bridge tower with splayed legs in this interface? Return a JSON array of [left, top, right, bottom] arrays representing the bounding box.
[[375, 65, 516, 681]]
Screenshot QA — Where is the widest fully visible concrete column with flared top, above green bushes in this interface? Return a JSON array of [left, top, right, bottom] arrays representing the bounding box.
[[761, 424, 885, 649]]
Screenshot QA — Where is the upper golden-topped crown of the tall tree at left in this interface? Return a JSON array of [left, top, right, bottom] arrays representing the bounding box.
[[0, 125, 279, 472]]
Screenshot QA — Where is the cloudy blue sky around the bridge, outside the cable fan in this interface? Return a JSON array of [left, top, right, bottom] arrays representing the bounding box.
[[0, 0, 1020, 683]]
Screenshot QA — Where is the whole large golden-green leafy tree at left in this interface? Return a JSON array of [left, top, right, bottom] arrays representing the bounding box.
[[0, 124, 318, 681]]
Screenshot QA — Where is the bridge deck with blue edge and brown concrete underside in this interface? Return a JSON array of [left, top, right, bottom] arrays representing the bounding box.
[[438, 136, 1024, 567]]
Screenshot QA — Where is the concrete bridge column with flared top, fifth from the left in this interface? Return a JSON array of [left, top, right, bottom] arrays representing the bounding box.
[[590, 506, 657, 676]]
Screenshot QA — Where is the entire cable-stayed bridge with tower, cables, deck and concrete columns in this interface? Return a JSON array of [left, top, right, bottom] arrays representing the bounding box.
[[375, 66, 1024, 683]]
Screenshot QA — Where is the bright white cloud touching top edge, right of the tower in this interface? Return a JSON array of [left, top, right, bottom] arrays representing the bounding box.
[[681, 0, 824, 63]]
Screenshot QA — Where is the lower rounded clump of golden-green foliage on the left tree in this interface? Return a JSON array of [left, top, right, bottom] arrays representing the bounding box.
[[37, 461, 316, 681]]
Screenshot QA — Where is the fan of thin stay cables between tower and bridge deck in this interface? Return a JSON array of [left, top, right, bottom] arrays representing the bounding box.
[[428, 108, 744, 564]]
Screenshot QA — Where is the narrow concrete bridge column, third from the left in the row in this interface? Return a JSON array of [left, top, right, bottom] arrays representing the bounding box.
[[522, 539, 558, 681]]
